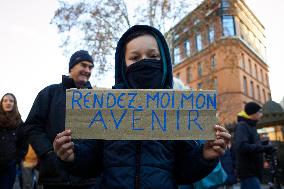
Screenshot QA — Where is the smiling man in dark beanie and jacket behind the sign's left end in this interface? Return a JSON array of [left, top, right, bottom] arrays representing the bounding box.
[[25, 50, 100, 189]]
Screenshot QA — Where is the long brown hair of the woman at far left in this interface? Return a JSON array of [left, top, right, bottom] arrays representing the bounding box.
[[0, 93, 23, 127]]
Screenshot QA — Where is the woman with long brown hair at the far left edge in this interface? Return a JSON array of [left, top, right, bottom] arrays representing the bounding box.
[[0, 93, 26, 189]]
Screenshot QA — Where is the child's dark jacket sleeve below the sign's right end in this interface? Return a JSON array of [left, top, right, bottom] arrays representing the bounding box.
[[175, 141, 218, 184]]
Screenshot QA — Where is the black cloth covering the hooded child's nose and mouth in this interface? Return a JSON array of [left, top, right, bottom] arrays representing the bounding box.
[[126, 59, 163, 89]]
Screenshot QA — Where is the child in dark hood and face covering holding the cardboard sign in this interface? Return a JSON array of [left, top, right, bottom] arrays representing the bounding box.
[[54, 25, 230, 189]]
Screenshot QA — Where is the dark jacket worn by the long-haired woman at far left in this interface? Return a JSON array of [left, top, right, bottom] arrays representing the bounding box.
[[0, 124, 28, 170]]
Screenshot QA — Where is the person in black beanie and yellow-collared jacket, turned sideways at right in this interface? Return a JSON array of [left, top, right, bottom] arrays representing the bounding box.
[[233, 102, 274, 189]]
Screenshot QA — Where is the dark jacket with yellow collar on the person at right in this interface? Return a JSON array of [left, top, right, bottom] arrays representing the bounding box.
[[234, 112, 271, 179]]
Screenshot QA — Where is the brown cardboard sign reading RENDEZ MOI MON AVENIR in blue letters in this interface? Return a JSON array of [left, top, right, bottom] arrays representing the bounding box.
[[65, 89, 217, 140]]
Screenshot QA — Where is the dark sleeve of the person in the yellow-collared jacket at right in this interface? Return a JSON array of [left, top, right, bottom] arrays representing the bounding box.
[[235, 124, 267, 154]]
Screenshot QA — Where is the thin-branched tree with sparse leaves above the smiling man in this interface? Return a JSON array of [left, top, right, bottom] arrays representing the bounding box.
[[51, 0, 200, 82]]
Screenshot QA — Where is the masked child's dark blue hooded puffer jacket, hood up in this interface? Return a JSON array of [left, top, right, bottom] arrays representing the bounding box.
[[71, 26, 217, 189]]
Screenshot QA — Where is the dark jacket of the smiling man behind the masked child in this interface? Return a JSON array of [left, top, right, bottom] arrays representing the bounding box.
[[25, 76, 98, 185]]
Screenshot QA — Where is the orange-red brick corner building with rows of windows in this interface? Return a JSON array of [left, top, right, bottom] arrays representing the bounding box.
[[166, 0, 271, 124]]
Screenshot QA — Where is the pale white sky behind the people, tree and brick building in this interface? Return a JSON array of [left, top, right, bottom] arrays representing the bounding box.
[[0, 0, 284, 120]]
